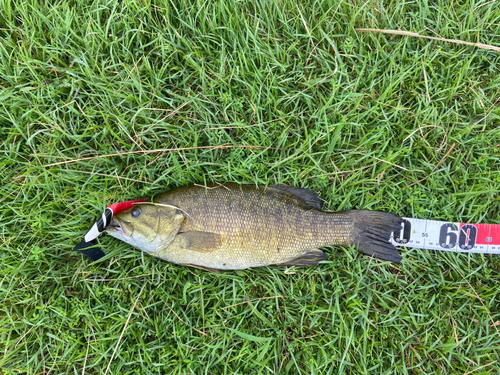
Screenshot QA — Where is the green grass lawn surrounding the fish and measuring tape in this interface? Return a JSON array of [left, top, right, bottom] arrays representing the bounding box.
[[0, 0, 500, 375]]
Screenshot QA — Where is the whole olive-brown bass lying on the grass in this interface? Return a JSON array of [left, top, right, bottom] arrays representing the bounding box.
[[106, 182, 402, 272]]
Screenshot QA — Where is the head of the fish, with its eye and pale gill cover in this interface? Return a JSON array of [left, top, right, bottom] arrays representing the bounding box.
[[106, 203, 185, 253]]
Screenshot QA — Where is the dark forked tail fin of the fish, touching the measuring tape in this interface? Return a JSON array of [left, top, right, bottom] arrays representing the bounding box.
[[351, 210, 403, 262]]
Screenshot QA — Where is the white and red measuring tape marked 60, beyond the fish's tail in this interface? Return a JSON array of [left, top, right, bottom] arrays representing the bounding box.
[[391, 217, 500, 254]]
